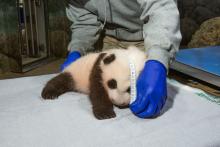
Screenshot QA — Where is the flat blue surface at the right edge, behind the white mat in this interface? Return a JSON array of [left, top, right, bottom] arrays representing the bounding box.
[[176, 46, 220, 76]]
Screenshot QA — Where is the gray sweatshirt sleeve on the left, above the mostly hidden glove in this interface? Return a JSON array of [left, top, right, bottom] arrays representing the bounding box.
[[66, 5, 101, 54]]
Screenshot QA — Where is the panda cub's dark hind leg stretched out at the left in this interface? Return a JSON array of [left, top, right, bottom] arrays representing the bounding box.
[[41, 72, 74, 99]]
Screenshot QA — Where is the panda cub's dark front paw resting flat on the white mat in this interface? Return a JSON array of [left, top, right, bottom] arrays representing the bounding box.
[[93, 107, 116, 120]]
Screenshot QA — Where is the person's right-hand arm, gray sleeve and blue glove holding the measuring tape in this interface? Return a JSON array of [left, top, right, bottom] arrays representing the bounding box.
[[130, 0, 181, 118]]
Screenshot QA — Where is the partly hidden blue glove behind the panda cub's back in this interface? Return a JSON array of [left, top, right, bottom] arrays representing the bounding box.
[[60, 51, 81, 71]]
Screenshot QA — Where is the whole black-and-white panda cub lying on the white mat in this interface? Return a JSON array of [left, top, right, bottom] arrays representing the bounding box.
[[41, 46, 147, 119]]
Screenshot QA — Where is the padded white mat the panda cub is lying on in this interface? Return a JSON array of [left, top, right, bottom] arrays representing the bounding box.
[[0, 75, 220, 147]]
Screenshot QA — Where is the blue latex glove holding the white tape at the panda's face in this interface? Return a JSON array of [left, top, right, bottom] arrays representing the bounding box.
[[130, 60, 167, 118]]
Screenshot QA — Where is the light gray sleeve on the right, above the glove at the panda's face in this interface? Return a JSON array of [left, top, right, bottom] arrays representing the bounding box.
[[138, 0, 182, 68]]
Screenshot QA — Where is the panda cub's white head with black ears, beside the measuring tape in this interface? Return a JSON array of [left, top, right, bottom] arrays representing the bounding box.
[[100, 46, 146, 106]]
